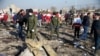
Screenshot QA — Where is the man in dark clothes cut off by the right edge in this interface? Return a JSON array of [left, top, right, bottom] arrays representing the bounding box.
[[91, 13, 100, 51]]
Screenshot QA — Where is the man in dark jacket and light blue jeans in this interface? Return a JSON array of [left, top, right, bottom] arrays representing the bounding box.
[[80, 13, 90, 40]]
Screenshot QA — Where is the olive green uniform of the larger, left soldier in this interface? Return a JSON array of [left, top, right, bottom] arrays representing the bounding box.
[[27, 15, 37, 39]]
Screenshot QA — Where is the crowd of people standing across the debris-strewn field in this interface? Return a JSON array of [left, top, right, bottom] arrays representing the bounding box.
[[0, 9, 100, 54]]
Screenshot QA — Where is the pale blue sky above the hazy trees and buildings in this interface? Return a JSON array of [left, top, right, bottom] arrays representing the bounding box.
[[0, 0, 100, 9]]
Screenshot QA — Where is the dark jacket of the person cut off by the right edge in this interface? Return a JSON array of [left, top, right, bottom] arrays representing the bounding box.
[[91, 20, 100, 37]]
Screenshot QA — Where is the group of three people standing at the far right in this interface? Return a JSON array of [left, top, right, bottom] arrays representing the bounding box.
[[72, 13, 100, 52]]
